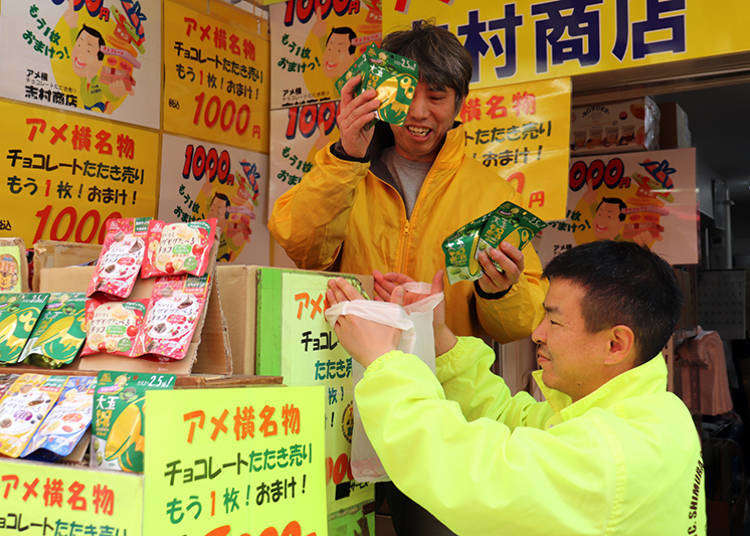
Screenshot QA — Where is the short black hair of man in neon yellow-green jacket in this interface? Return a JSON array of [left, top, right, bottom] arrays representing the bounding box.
[[544, 240, 682, 365]]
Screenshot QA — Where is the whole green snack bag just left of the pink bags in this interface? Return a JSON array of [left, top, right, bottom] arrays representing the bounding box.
[[19, 292, 86, 368]]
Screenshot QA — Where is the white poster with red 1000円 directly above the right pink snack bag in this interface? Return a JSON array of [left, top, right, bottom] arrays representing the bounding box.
[[159, 135, 270, 265]]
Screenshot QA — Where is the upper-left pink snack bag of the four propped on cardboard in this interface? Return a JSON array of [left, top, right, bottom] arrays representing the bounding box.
[[86, 218, 151, 298]]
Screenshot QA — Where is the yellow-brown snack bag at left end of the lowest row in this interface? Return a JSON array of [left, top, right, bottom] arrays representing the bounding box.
[[0, 374, 67, 458]]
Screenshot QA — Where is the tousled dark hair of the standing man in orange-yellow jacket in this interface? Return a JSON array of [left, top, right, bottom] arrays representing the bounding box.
[[381, 21, 472, 112]]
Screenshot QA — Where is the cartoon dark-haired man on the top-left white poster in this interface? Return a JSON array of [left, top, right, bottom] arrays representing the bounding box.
[[63, 0, 132, 113]]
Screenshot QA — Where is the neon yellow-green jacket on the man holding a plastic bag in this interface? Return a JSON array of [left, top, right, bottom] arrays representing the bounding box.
[[355, 337, 706, 536]]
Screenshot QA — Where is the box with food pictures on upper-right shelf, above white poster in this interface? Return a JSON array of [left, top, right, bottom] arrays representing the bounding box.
[[570, 97, 659, 156]]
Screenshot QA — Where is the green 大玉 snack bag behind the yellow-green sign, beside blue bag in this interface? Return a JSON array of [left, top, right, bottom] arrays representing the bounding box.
[[91, 371, 176, 473]]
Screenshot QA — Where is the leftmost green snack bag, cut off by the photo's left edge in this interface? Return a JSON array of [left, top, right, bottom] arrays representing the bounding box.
[[0, 292, 49, 364]]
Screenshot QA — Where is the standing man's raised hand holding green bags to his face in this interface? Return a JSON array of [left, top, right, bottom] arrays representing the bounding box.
[[336, 74, 380, 158]]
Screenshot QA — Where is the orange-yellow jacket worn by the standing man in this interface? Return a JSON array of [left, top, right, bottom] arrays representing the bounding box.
[[268, 125, 547, 342]]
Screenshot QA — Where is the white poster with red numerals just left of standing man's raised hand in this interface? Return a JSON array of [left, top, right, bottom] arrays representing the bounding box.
[[268, 101, 339, 222]]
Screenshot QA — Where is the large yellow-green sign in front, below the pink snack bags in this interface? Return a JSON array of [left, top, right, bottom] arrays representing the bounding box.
[[143, 387, 326, 536]]
